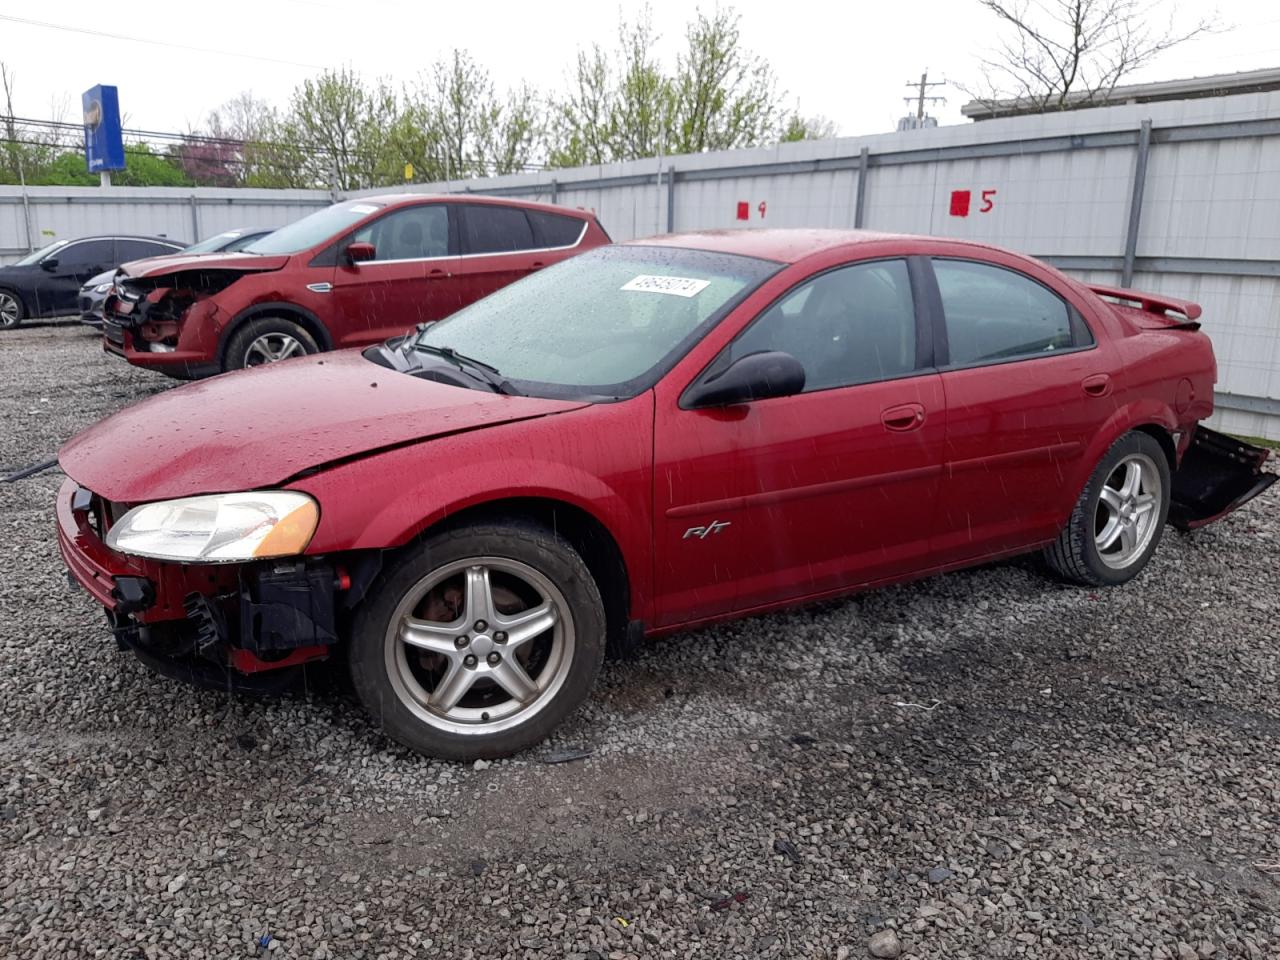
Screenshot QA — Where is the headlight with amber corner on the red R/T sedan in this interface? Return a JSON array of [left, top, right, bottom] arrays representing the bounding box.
[[106, 490, 320, 563]]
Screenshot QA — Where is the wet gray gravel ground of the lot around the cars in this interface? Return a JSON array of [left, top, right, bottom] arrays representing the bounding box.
[[0, 323, 1280, 960]]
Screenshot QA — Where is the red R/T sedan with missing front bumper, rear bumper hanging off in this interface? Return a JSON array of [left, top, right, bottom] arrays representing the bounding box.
[[58, 232, 1275, 758]]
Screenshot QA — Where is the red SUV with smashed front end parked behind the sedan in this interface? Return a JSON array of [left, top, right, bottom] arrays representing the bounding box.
[[102, 193, 609, 379]]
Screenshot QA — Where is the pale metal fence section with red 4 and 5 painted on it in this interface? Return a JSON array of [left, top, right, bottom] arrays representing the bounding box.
[[363, 86, 1280, 438]]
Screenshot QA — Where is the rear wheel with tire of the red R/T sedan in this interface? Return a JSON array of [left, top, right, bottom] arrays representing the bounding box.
[[1044, 431, 1171, 586]]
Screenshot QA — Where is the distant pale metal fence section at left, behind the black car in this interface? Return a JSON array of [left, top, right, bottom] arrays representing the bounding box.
[[0, 187, 333, 264]]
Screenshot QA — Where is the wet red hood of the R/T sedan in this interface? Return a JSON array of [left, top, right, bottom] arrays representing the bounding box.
[[58, 351, 586, 503]]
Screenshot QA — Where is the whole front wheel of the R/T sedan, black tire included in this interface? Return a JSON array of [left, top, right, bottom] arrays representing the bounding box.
[[349, 524, 605, 760]]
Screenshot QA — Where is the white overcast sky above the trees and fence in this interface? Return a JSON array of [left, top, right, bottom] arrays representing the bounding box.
[[0, 0, 1280, 136]]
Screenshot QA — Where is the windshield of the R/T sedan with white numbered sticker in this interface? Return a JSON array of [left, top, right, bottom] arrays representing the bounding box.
[[415, 246, 778, 398]]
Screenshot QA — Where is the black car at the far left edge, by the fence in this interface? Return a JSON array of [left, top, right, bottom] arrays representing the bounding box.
[[0, 237, 186, 330]]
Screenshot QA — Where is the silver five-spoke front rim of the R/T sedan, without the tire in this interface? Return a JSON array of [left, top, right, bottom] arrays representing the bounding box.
[[384, 557, 575, 735]]
